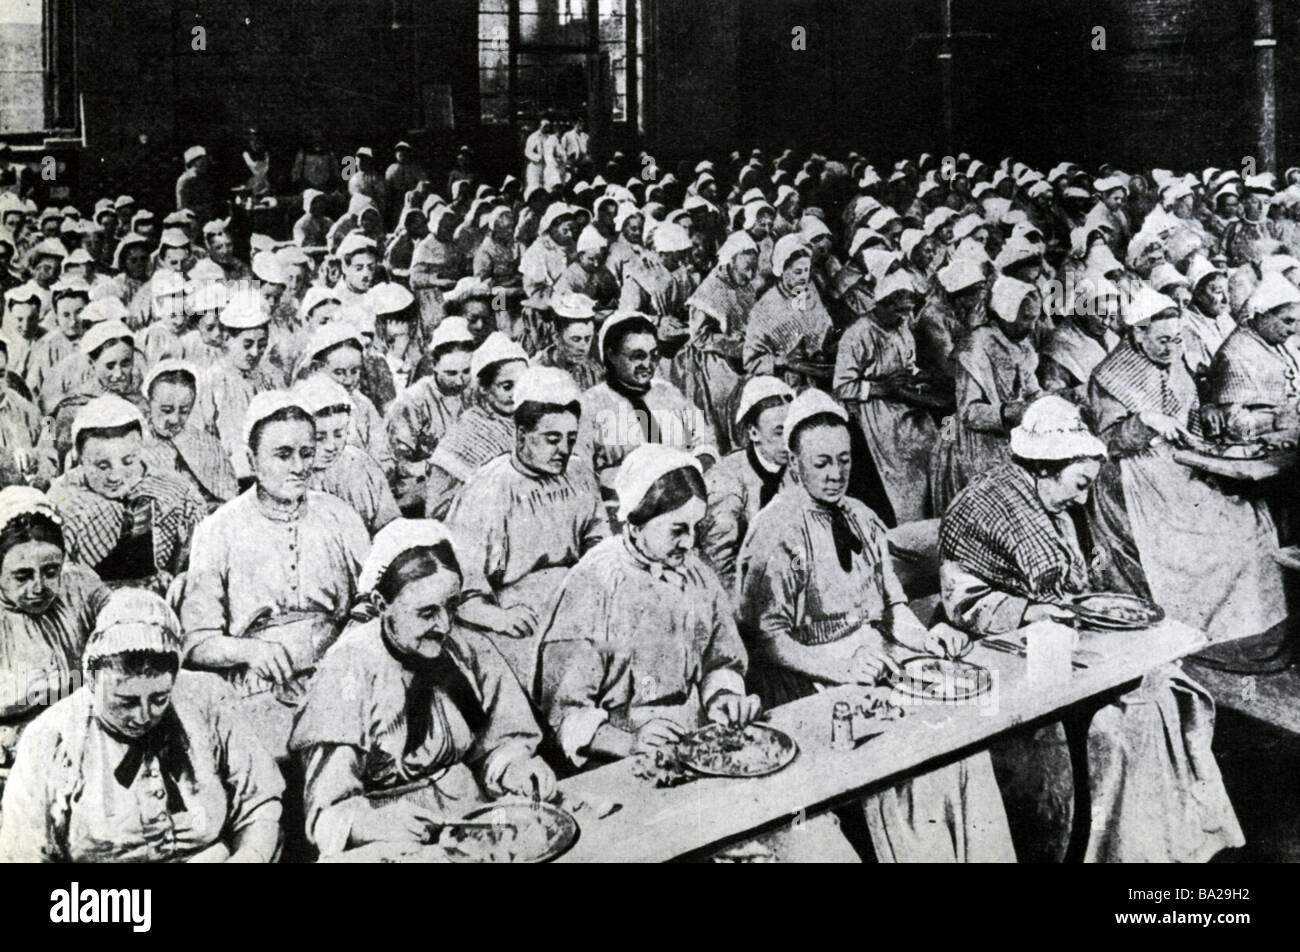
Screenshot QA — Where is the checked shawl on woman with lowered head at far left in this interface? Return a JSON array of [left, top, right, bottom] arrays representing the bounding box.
[[49, 467, 207, 574]]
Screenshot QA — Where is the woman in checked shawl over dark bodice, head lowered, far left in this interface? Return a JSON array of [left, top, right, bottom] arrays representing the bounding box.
[[49, 394, 205, 594]]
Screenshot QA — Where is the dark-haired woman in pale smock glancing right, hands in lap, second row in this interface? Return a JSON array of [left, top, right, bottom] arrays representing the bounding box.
[[447, 367, 610, 684]]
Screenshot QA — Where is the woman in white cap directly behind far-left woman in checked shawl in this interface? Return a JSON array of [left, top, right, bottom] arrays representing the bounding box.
[[140, 360, 239, 512]]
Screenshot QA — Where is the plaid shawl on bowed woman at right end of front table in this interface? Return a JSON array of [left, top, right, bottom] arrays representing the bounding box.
[[939, 463, 1088, 598]]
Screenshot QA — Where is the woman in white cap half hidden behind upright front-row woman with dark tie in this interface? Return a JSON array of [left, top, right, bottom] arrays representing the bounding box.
[[699, 377, 794, 594]]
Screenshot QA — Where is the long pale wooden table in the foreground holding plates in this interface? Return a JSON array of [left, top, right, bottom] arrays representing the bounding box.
[[559, 622, 1206, 862]]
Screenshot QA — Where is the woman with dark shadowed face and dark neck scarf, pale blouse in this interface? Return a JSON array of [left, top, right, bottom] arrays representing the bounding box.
[[576, 313, 719, 520]]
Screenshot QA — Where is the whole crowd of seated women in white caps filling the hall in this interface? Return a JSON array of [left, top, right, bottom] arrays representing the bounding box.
[[0, 143, 1300, 861]]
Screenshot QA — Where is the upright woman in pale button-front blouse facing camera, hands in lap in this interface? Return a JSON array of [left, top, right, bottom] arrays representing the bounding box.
[[181, 390, 369, 749]]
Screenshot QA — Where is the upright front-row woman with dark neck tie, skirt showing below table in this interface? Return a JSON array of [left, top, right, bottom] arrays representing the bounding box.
[[737, 390, 1015, 862]]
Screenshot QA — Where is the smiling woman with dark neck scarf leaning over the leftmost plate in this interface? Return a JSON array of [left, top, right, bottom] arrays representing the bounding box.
[[289, 519, 555, 857]]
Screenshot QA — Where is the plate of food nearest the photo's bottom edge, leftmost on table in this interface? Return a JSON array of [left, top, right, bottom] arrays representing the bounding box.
[[437, 800, 579, 862]]
